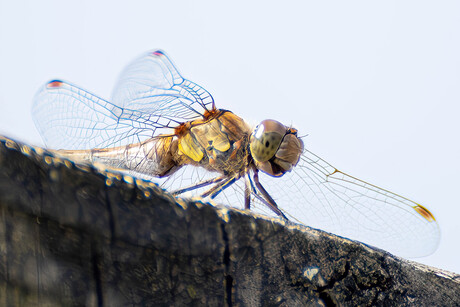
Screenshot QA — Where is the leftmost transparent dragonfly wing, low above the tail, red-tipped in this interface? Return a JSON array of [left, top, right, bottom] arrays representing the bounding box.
[[32, 80, 173, 149]]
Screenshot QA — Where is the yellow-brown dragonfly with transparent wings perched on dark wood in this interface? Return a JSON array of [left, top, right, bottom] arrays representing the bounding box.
[[32, 50, 440, 257]]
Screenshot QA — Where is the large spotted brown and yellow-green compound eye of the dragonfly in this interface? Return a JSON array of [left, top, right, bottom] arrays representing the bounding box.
[[249, 119, 287, 162]]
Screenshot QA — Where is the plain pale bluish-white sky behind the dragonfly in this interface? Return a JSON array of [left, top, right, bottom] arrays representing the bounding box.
[[0, 0, 460, 273]]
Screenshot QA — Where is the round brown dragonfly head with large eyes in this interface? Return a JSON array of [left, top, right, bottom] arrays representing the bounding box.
[[249, 119, 303, 176]]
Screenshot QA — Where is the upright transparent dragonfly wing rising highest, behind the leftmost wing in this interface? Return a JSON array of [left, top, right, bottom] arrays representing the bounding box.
[[112, 50, 214, 123]]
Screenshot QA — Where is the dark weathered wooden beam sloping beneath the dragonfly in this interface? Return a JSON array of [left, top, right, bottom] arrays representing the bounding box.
[[0, 137, 460, 306]]
